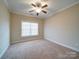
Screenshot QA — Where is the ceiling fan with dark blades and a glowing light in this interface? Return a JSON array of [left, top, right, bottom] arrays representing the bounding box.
[[29, 2, 48, 16]]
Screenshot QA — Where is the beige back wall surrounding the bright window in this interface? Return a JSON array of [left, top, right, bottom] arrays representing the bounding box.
[[10, 13, 43, 44]]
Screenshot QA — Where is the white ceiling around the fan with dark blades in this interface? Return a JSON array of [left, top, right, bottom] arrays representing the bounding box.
[[5, 0, 79, 18]]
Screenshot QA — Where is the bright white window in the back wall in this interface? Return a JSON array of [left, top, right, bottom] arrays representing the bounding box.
[[21, 22, 38, 36]]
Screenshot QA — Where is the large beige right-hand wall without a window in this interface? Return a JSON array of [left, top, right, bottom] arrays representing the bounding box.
[[44, 4, 79, 51]]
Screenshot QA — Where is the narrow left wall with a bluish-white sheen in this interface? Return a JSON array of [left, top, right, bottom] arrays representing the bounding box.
[[0, 0, 10, 57]]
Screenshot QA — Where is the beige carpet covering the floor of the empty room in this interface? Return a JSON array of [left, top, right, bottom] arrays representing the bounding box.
[[2, 40, 79, 59]]
